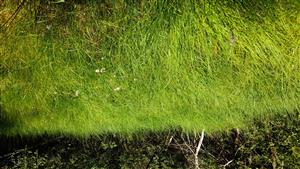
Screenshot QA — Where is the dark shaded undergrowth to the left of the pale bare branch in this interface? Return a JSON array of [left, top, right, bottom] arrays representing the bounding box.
[[0, 133, 187, 168]]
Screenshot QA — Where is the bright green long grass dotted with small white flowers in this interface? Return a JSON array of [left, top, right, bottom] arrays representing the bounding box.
[[0, 0, 300, 136]]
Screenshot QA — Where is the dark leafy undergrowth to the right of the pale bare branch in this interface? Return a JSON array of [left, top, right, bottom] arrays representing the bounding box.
[[204, 111, 300, 169]]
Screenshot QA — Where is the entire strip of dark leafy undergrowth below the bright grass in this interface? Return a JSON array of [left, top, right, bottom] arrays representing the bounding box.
[[0, 113, 300, 169]]
